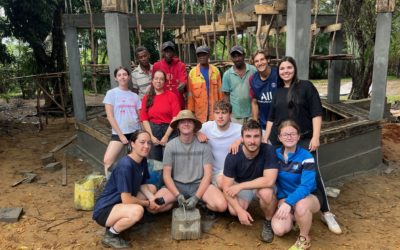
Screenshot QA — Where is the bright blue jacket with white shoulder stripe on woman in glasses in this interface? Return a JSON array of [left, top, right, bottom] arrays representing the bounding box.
[[276, 146, 317, 206]]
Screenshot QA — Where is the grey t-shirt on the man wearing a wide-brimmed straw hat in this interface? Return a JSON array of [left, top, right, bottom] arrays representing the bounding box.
[[163, 137, 212, 183]]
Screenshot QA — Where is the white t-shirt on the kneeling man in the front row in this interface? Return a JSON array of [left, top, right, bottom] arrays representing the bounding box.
[[200, 121, 242, 175]]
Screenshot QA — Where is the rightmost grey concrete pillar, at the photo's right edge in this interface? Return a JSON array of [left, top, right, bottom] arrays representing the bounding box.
[[369, 13, 392, 120]]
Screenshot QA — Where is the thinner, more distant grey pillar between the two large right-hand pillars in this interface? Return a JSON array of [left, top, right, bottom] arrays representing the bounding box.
[[328, 30, 343, 103]]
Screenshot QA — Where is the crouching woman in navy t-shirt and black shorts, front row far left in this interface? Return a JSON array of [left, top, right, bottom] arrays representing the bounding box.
[[93, 130, 159, 248]]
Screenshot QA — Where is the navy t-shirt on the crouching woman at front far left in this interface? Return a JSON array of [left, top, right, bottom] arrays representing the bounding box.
[[93, 156, 149, 219]]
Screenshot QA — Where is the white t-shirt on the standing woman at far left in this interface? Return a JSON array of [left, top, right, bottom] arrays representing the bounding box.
[[103, 87, 142, 135]]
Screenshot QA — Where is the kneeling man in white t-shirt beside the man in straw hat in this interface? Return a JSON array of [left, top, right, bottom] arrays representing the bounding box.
[[198, 101, 242, 189]]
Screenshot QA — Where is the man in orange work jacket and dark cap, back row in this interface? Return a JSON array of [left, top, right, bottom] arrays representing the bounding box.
[[188, 46, 224, 123]]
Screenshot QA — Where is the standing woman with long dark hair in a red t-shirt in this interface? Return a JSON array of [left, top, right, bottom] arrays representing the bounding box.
[[140, 70, 181, 161]]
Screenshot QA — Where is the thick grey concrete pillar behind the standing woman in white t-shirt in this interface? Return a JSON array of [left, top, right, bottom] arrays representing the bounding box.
[[104, 12, 132, 88]]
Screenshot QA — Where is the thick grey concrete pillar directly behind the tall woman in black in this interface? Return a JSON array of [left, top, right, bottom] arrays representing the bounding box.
[[286, 0, 311, 80]]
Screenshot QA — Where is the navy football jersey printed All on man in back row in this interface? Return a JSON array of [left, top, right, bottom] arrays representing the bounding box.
[[249, 67, 278, 129]]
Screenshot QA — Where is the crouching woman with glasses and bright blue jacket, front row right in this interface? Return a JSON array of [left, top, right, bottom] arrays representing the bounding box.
[[272, 120, 321, 249]]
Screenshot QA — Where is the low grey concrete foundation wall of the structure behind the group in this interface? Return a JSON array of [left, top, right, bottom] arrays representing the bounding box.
[[77, 101, 382, 181]]
